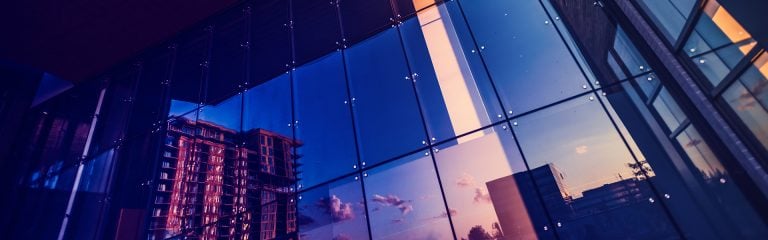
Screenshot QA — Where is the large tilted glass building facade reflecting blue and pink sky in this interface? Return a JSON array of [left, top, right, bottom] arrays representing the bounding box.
[[1, 0, 768, 240]]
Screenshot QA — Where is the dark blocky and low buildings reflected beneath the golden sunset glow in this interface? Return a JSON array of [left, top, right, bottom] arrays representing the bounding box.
[[486, 164, 674, 239]]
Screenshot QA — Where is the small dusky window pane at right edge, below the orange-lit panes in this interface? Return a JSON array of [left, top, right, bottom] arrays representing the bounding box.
[[723, 82, 768, 149]]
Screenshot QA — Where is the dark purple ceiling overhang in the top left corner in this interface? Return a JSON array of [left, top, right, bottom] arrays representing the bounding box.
[[0, 0, 240, 83]]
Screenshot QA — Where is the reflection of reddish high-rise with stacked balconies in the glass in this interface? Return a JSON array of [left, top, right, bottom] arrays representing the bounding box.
[[150, 118, 296, 239]]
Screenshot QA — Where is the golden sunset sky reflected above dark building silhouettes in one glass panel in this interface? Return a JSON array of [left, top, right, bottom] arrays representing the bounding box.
[[513, 95, 634, 197]]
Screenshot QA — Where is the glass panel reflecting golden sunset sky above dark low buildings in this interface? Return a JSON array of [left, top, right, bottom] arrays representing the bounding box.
[[513, 95, 678, 239]]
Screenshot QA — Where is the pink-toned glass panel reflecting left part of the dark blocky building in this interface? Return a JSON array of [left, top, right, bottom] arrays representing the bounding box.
[[435, 123, 562, 239]]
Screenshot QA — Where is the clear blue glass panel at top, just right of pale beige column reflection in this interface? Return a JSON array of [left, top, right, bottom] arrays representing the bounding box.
[[461, 0, 588, 114]]
